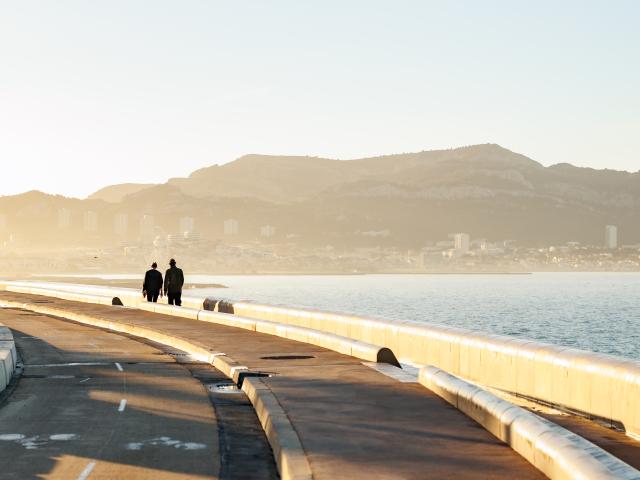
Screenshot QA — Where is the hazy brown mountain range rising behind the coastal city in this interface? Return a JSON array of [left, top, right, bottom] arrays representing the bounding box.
[[0, 144, 640, 248]]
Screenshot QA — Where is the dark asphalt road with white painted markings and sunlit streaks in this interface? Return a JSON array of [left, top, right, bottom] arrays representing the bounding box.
[[0, 309, 277, 480]]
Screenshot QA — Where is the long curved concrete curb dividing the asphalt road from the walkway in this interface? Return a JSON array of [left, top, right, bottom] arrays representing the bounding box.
[[0, 300, 313, 480]]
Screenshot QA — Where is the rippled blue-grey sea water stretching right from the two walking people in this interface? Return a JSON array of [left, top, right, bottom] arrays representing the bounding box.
[[188, 273, 640, 359]]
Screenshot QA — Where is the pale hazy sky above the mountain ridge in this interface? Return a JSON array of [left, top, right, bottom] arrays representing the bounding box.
[[0, 0, 640, 196]]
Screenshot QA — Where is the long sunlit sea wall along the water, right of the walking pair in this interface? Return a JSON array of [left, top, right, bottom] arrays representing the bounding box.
[[206, 299, 640, 437]]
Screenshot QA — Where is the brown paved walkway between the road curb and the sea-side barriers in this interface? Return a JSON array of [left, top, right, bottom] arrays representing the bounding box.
[[0, 292, 543, 480]]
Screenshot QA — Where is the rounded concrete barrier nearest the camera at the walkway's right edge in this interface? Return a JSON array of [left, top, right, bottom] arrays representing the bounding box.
[[419, 366, 640, 480]]
